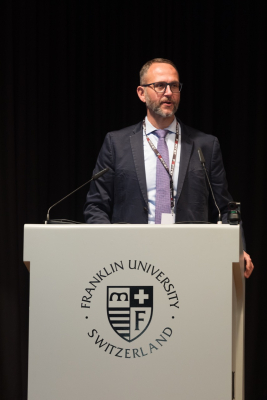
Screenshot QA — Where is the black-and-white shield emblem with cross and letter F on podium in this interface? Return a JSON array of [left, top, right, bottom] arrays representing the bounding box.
[[107, 286, 153, 342]]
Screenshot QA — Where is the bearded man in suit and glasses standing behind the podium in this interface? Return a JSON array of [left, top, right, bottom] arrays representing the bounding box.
[[84, 58, 254, 277]]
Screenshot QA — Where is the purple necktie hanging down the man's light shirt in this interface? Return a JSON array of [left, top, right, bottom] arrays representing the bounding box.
[[155, 129, 171, 224]]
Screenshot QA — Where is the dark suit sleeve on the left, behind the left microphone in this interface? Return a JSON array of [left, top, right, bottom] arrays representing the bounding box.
[[84, 134, 114, 224]]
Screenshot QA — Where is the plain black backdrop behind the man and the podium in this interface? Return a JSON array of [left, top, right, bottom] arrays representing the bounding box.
[[0, 0, 267, 400]]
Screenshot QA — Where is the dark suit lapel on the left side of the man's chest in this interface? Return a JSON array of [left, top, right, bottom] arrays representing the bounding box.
[[130, 122, 148, 204]]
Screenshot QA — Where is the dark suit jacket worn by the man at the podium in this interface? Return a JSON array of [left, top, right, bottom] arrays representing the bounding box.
[[84, 121, 244, 239]]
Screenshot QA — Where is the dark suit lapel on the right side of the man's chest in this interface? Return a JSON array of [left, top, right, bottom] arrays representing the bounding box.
[[176, 121, 193, 205]]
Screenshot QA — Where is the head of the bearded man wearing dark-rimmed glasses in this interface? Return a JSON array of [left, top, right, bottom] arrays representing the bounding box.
[[137, 58, 180, 123]]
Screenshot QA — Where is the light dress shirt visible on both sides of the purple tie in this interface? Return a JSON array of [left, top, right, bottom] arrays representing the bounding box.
[[143, 117, 181, 224]]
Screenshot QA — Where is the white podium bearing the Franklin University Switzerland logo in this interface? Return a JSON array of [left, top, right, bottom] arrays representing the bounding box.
[[24, 225, 245, 400]]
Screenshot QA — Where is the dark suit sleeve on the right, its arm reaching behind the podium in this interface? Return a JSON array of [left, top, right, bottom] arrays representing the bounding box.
[[210, 138, 246, 250]]
